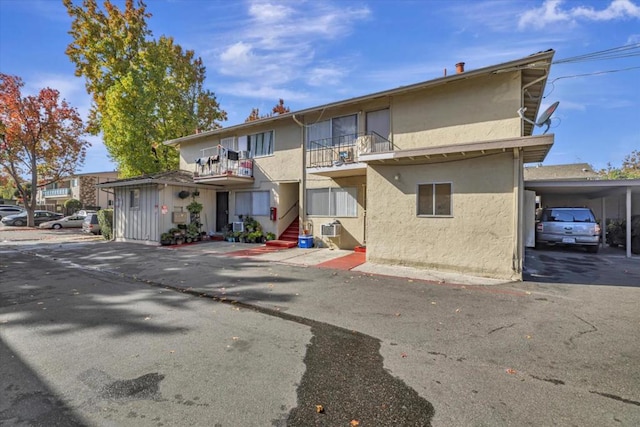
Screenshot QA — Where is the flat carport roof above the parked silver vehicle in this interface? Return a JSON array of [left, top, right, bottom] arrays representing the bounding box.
[[524, 179, 640, 199]]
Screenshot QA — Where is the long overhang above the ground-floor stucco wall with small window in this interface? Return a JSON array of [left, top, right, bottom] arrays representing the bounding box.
[[359, 134, 554, 165]]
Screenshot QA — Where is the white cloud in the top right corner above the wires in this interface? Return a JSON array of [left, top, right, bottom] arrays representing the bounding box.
[[518, 0, 640, 30]]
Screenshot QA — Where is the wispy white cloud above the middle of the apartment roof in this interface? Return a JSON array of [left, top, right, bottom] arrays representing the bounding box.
[[212, 1, 371, 95]]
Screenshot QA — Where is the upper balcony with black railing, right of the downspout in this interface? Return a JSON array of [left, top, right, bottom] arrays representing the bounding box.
[[306, 132, 393, 177]]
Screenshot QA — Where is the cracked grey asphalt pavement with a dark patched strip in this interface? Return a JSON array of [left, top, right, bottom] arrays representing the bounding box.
[[0, 231, 640, 426]]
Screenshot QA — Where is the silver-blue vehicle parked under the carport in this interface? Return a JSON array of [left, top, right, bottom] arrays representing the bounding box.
[[536, 207, 600, 253]]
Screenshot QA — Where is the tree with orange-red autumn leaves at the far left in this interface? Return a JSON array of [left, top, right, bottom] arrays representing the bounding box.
[[0, 73, 90, 226]]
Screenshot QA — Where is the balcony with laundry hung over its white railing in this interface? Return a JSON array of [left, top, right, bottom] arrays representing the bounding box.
[[193, 152, 253, 185]]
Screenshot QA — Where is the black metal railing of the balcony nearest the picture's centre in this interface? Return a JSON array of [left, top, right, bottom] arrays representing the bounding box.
[[307, 132, 393, 168]]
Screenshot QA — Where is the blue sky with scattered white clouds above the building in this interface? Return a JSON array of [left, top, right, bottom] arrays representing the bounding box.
[[0, 0, 640, 172]]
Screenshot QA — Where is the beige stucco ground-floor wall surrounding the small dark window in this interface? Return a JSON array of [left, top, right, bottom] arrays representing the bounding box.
[[367, 153, 519, 279]]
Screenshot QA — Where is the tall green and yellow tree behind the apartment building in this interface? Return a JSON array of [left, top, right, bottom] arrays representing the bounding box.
[[64, 0, 227, 177]]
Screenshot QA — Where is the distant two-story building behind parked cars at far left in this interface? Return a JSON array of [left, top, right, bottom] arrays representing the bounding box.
[[36, 171, 118, 214]]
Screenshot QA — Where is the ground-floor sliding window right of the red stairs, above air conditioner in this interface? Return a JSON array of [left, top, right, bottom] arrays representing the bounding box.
[[307, 187, 358, 217]]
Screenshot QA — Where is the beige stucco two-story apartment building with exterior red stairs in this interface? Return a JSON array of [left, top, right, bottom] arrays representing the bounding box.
[[99, 50, 554, 279]]
